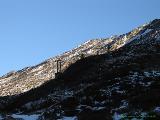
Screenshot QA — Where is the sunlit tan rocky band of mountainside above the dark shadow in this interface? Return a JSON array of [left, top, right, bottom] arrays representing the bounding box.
[[0, 19, 158, 96]]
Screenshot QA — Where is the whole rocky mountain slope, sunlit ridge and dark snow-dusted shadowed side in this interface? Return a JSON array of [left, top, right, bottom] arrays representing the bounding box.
[[0, 19, 160, 120]]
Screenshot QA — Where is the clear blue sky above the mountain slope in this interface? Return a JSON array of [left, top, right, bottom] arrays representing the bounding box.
[[0, 0, 160, 75]]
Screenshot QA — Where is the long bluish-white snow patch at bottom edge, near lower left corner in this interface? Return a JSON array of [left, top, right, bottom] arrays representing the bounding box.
[[12, 114, 39, 120]]
